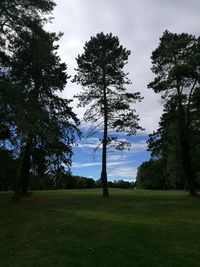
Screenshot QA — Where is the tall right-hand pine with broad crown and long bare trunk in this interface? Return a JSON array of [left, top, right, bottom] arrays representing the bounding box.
[[149, 31, 200, 195]]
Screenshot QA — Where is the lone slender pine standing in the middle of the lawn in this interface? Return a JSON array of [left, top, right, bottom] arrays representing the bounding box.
[[74, 32, 141, 197]]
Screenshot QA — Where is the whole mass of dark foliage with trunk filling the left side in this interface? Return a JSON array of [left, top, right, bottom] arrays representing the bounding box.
[[0, 0, 80, 197]]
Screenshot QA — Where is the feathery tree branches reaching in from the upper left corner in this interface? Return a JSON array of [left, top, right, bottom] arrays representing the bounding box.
[[0, 0, 55, 144]]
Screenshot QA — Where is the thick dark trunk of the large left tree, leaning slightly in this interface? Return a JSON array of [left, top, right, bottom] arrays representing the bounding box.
[[13, 137, 32, 199]]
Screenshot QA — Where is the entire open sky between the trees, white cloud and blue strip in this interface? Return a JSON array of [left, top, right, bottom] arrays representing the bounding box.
[[47, 0, 200, 181]]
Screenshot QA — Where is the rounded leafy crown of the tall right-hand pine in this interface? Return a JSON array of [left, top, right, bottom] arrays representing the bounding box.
[[149, 31, 200, 97]]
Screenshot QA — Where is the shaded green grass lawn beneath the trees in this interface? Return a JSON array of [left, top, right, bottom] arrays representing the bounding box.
[[0, 189, 200, 267]]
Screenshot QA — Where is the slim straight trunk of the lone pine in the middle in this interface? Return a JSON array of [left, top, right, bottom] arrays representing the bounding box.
[[101, 71, 109, 197]]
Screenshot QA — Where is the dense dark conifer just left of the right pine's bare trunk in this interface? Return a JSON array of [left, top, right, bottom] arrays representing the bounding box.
[[147, 99, 187, 189]]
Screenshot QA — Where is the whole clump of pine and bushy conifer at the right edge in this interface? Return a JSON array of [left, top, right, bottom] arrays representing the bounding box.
[[149, 31, 200, 195]]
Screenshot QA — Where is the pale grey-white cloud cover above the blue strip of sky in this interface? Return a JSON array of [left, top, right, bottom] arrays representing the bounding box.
[[48, 0, 200, 133]]
